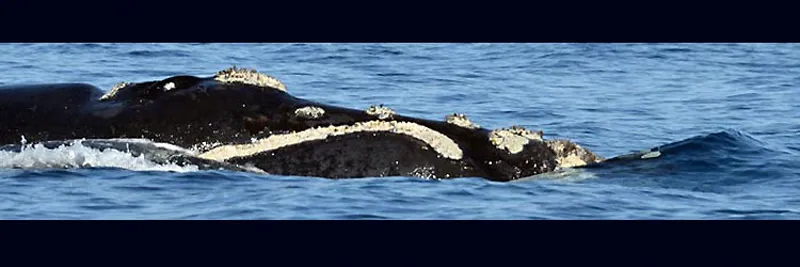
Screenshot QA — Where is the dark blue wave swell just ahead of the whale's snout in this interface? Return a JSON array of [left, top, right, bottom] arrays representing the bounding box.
[[586, 129, 796, 192]]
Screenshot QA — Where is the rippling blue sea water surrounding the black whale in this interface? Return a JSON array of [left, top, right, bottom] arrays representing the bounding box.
[[0, 44, 800, 219]]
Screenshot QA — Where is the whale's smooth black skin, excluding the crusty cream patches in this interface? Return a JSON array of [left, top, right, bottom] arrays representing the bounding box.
[[0, 69, 600, 181]]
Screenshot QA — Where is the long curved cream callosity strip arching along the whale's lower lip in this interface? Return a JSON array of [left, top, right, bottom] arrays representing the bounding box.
[[200, 121, 463, 160]]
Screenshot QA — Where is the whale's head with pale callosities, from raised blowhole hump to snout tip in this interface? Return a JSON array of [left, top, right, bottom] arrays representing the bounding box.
[[89, 67, 602, 181]]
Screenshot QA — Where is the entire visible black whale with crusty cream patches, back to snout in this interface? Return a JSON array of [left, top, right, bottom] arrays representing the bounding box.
[[0, 66, 606, 181]]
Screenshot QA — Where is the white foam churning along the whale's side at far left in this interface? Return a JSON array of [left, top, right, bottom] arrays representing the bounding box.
[[0, 141, 199, 172]]
